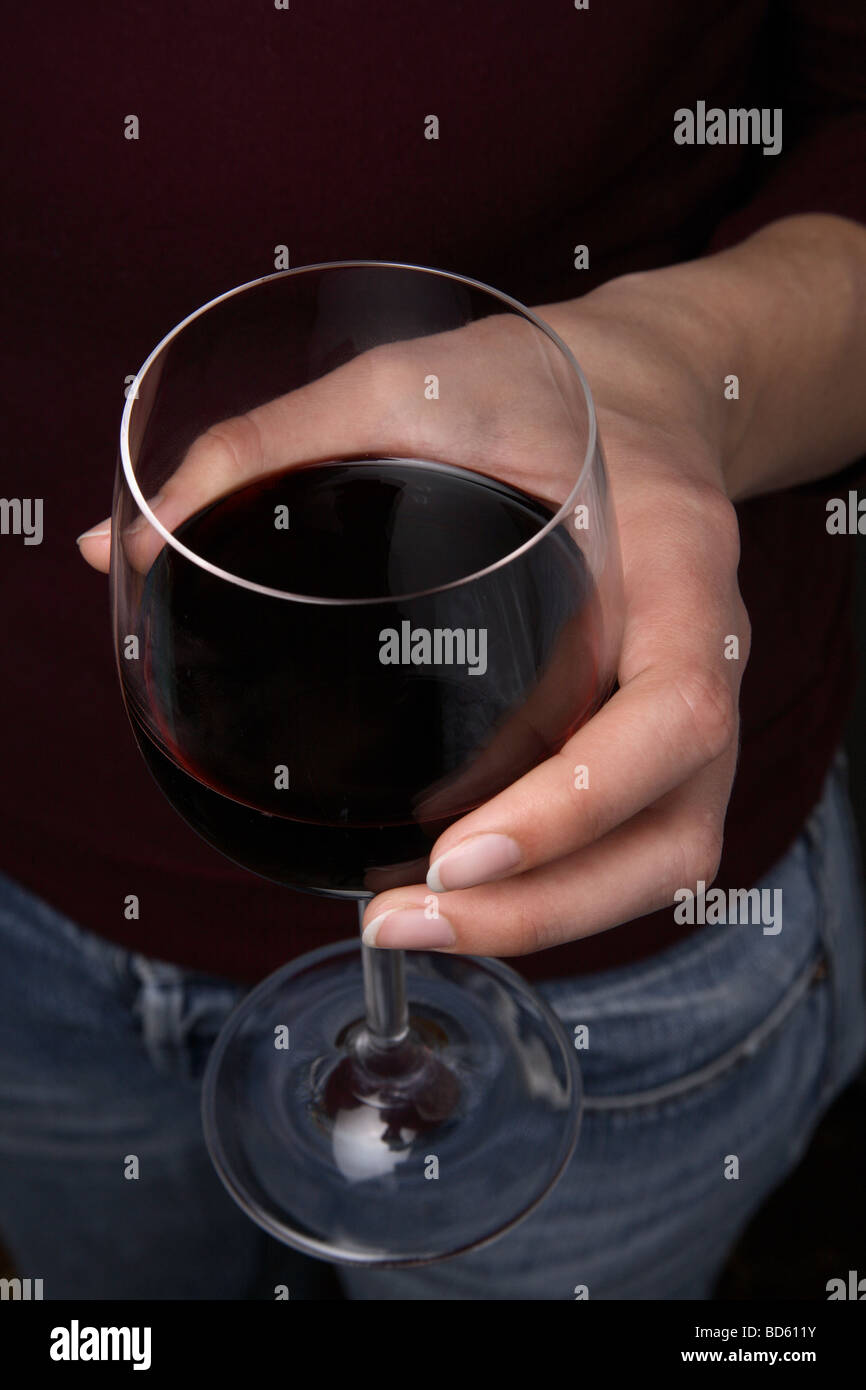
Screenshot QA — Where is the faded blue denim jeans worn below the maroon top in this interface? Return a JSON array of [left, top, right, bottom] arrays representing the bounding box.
[[0, 760, 866, 1300]]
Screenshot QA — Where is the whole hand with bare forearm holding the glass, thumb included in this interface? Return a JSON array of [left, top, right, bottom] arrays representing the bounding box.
[[81, 214, 866, 956]]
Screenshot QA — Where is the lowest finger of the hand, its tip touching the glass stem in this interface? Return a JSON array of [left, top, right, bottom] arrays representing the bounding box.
[[364, 758, 730, 956]]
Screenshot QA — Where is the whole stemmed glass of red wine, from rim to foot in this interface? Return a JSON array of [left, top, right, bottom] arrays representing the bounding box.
[[111, 261, 621, 1265]]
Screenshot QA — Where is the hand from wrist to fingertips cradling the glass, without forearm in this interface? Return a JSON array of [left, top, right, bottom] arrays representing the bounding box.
[[79, 269, 748, 955]]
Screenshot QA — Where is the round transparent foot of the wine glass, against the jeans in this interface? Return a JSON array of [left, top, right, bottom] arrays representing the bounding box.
[[202, 941, 581, 1266]]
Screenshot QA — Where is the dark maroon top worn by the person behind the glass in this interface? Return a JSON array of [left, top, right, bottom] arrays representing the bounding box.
[[6, 0, 866, 980]]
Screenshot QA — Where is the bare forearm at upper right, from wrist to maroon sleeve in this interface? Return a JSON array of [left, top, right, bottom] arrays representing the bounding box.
[[567, 214, 866, 500]]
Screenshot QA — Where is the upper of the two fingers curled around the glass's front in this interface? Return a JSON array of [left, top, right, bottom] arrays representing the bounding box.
[[427, 489, 748, 892]]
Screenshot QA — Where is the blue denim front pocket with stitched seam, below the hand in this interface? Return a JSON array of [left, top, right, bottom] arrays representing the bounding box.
[[541, 778, 834, 1109]]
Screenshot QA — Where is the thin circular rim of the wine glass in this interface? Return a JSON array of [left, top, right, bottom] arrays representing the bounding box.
[[120, 260, 598, 607]]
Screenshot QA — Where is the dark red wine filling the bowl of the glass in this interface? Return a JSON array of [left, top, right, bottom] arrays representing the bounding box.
[[121, 459, 606, 894]]
